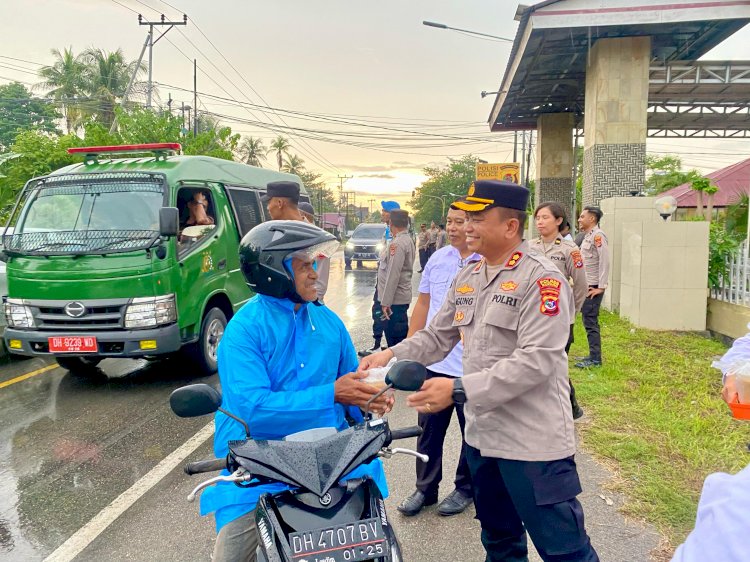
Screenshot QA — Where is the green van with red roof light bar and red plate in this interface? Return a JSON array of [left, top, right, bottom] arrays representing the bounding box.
[[2, 143, 307, 374]]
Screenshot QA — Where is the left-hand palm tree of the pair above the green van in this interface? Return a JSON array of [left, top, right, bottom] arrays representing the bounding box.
[[35, 47, 86, 133]]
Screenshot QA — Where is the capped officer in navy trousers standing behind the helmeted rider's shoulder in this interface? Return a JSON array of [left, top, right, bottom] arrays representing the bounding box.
[[377, 210, 416, 347]]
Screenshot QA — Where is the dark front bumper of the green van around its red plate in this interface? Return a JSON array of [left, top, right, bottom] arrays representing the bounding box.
[[4, 324, 182, 357]]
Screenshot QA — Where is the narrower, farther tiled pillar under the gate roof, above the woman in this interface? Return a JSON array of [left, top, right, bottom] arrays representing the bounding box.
[[534, 113, 575, 214]]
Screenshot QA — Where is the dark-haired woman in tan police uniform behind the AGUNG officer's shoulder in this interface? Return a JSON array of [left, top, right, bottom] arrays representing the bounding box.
[[529, 201, 588, 420]]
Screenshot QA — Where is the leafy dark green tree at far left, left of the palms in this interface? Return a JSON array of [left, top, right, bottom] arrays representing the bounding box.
[[0, 82, 61, 151]]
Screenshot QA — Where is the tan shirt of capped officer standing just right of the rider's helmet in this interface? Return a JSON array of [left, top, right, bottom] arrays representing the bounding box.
[[378, 231, 415, 306]]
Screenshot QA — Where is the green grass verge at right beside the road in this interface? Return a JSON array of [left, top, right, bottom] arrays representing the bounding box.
[[570, 311, 750, 546]]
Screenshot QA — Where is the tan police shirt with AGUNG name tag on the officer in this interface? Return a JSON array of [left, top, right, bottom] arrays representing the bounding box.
[[391, 242, 575, 461]]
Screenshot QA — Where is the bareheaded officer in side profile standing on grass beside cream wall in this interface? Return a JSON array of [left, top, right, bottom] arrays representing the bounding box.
[[576, 207, 609, 369]]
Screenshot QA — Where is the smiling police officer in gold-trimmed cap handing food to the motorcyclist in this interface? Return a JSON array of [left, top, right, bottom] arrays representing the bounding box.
[[359, 180, 599, 562]]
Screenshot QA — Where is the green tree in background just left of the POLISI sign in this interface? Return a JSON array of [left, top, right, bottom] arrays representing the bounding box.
[[409, 155, 477, 224]]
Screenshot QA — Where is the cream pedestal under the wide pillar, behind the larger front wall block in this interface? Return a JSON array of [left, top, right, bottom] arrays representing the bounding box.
[[600, 197, 662, 312]]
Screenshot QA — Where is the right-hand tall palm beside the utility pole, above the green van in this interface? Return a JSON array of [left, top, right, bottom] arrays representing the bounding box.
[[82, 48, 147, 125]]
